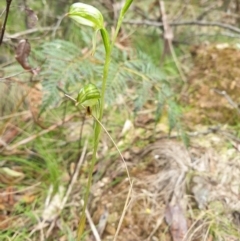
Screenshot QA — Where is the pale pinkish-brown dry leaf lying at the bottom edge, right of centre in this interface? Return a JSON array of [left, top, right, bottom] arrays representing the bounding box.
[[165, 204, 188, 241]]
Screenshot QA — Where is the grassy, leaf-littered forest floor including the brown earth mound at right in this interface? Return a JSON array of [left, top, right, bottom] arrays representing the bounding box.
[[0, 43, 240, 241]]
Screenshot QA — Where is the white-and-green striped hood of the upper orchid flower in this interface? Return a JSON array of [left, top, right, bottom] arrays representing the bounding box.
[[68, 2, 104, 30]]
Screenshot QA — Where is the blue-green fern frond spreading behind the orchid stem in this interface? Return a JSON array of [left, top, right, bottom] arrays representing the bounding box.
[[38, 36, 181, 136]]
